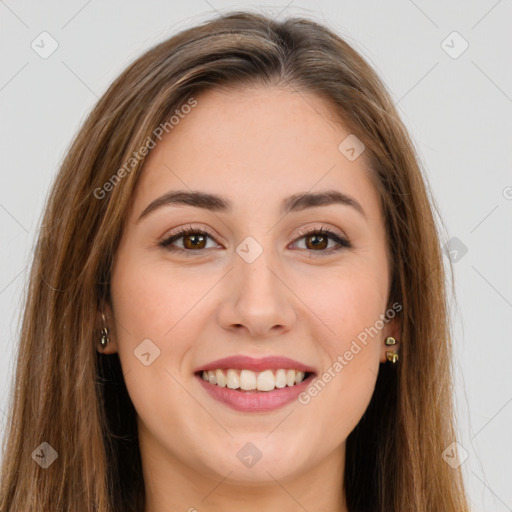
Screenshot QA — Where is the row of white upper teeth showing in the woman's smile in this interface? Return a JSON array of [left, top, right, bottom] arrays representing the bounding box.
[[201, 369, 305, 391]]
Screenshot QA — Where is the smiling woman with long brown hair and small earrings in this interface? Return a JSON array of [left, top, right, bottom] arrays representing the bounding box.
[[1, 12, 468, 512]]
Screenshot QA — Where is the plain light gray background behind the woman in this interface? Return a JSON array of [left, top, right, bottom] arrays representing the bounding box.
[[0, 0, 512, 512]]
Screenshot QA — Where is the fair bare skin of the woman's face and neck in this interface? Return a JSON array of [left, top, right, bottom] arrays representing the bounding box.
[[99, 86, 399, 512]]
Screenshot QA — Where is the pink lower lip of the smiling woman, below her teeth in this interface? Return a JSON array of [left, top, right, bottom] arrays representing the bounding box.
[[196, 374, 314, 412]]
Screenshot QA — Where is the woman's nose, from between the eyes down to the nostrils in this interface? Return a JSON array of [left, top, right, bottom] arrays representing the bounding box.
[[218, 244, 297, 339]]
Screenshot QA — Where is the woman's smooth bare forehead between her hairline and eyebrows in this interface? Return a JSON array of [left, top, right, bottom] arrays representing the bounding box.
[[135, 87, 377, 222]]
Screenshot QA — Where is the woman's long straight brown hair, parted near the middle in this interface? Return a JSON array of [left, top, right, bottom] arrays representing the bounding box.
[[0, 12, 468, 512]]
